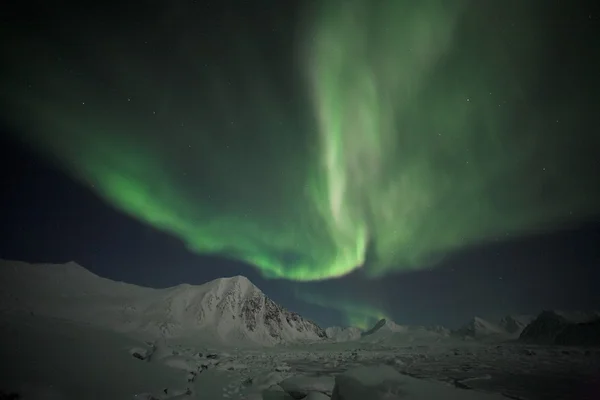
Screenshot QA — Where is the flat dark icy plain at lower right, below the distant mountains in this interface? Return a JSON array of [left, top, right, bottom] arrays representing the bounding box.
[[282, 341, 600, 400]]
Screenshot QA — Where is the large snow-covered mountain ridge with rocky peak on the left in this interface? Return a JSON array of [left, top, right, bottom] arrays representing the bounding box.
[[0, 260, 326, 344]]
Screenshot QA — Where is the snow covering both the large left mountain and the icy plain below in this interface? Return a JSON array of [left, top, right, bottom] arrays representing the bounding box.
[[0, 261, 600, 400]]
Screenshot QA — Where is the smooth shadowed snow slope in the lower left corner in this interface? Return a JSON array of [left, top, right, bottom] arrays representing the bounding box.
[[0, 314, 185, 400]]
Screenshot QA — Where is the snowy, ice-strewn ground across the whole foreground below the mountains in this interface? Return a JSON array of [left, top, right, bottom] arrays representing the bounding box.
[[0, 315, 600, 400]]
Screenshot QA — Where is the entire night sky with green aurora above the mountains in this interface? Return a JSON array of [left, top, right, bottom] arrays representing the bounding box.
[[0, 0, 600, 327]]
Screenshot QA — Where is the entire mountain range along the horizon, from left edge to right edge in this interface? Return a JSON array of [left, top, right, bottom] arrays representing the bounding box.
[[0, 260, 600, 345]]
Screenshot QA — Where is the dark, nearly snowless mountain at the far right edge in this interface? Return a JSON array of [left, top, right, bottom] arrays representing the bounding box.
[[519, 311, 600, 345]]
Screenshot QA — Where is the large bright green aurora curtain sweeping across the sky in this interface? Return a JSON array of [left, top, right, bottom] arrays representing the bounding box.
[[0, 0, 600, 281]]
